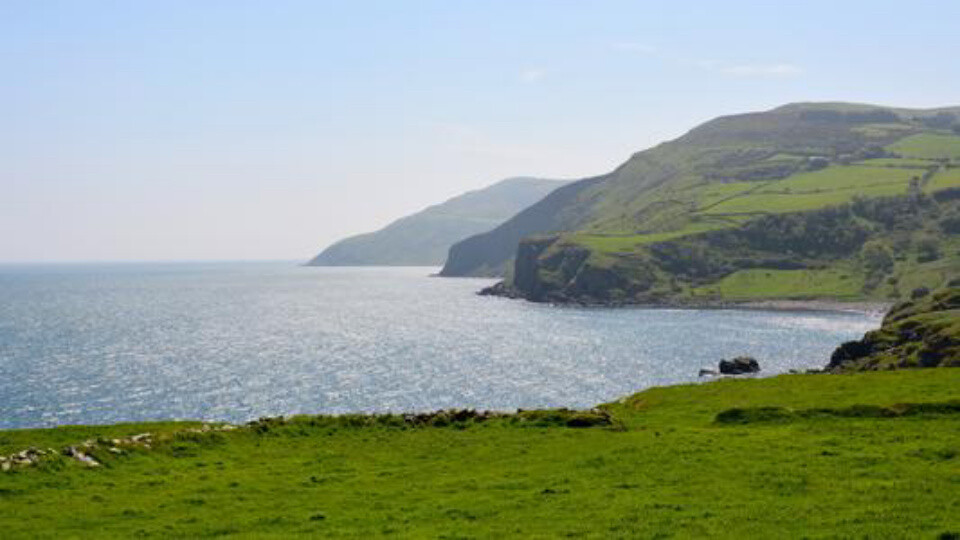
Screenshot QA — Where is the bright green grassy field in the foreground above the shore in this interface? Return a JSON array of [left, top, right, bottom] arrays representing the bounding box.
[[0, 369, 960, 538]]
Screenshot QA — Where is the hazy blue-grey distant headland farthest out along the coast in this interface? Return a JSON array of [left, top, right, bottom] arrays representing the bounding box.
[[308, 178, 564, 266]]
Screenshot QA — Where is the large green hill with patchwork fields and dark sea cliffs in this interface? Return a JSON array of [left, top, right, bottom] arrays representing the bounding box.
[[441, 103, 960, 303]]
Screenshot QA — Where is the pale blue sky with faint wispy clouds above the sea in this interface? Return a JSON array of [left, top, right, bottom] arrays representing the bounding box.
[[0, 0, 960, 262]]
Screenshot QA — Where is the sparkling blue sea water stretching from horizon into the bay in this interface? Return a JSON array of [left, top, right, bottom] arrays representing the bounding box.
[[0, 263, 879, 428]]
